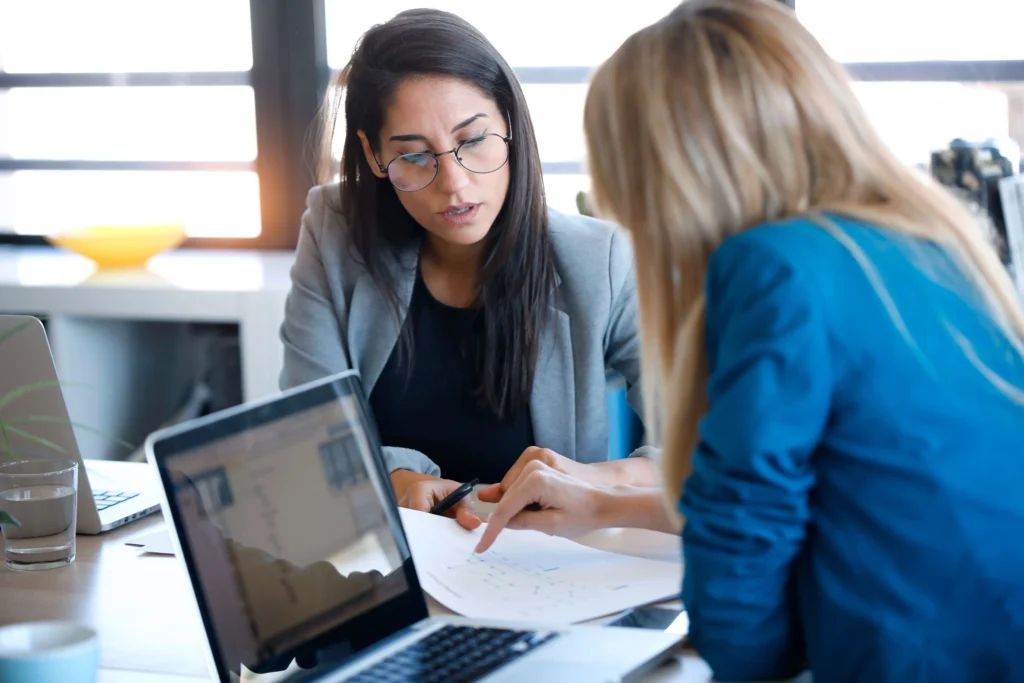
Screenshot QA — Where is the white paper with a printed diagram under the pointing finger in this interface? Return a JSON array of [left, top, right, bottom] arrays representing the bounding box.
[[400, 508, 683, 624]]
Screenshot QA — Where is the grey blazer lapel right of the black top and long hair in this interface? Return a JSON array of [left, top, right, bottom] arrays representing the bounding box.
[[529, 306, 577, 460]]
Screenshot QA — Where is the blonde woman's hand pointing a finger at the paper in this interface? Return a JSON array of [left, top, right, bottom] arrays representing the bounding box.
[[476, 456, 611, 553]]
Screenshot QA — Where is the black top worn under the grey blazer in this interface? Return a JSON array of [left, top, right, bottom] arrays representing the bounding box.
[[370, 275, 534, 483]]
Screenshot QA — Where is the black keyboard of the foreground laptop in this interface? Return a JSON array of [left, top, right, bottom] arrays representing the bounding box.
[[346, 626, 558, 683]]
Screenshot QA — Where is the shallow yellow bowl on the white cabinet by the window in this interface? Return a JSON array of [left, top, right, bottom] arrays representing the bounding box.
[[47, 224, 185, 268]]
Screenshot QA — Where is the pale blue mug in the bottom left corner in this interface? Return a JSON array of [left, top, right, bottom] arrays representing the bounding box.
[[0, 622, 99, 683]]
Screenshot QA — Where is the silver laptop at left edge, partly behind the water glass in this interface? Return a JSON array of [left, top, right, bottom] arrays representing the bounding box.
[[0, 315, 160, 533]]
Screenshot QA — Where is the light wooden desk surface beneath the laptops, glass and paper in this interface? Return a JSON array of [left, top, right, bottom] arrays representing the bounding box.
[[0, 515, 710, 683]]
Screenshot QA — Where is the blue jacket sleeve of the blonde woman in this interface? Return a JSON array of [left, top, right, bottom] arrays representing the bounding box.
[[680, 236, 833, 681]]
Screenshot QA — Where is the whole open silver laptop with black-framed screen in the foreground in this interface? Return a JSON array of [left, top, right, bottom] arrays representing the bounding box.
[[145, 372, 682, 683]]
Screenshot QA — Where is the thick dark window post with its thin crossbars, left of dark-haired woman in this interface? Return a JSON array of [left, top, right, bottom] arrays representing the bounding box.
[[0, 0, 330, 250]]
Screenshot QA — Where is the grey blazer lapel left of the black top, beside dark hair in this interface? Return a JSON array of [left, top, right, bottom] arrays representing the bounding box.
[[348, 249, 419, 397]]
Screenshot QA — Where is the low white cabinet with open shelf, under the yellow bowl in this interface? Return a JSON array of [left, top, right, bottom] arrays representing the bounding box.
[[0, 246, 294, 459]]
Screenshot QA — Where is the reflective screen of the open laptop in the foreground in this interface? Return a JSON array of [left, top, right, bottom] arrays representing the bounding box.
[[153, 376, 426, 679]]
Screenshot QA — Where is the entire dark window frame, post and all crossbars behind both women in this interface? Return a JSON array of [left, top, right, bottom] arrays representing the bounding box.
[[0, 0, 1024, 249]]
